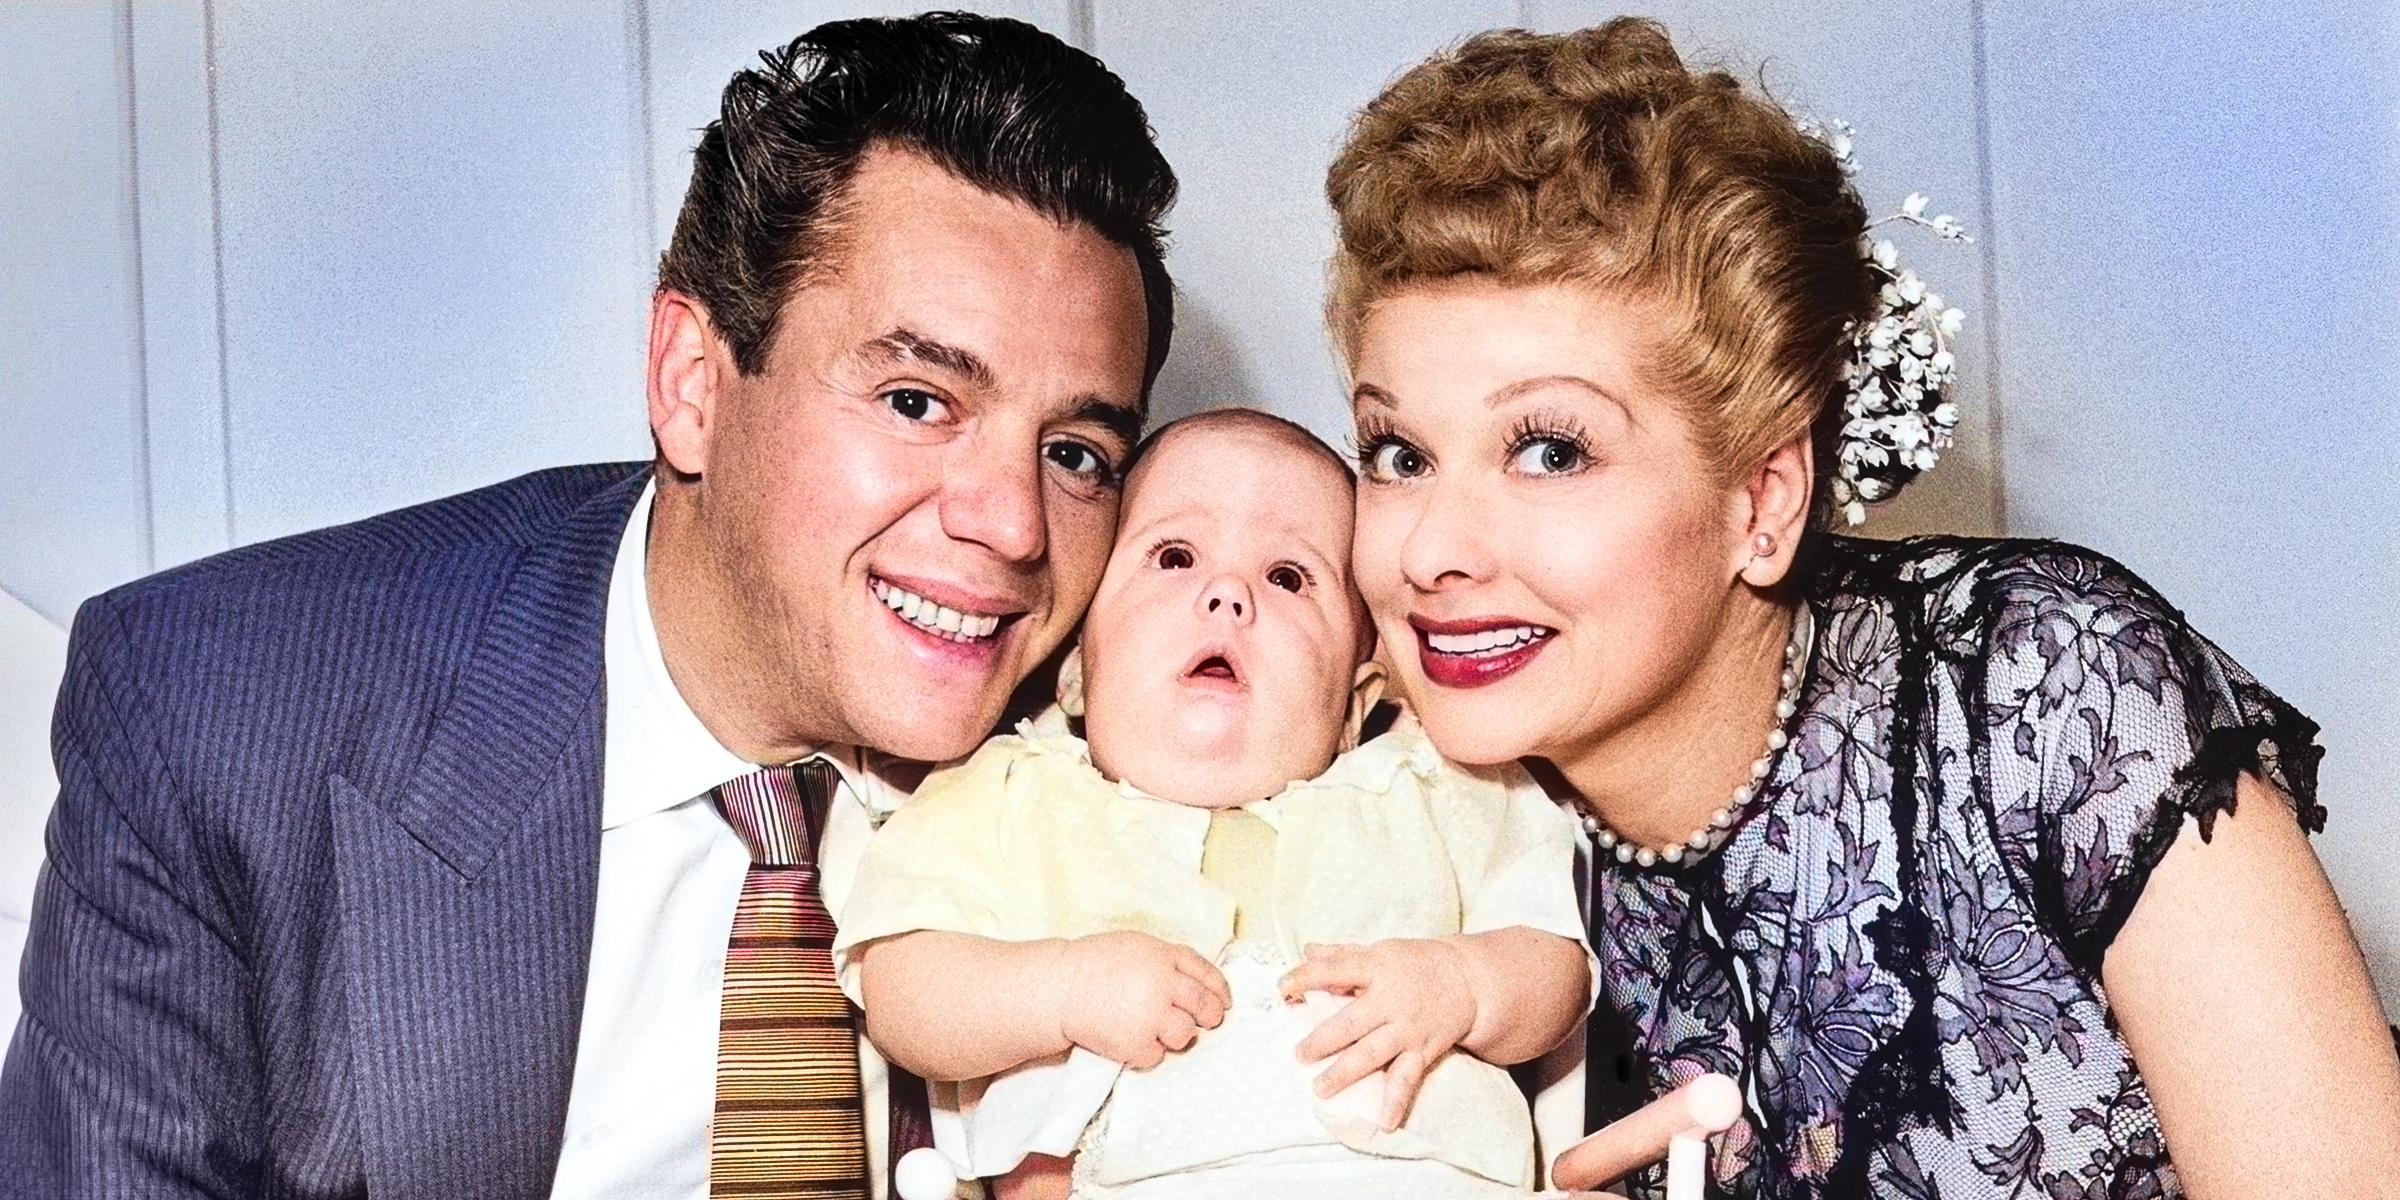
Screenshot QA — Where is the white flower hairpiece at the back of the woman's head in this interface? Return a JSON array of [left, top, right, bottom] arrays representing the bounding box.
[[1798, 118, 1973, 526]]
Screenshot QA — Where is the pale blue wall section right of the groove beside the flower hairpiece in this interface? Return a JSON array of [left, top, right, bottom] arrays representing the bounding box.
[[1990, 0, 2400, 988]]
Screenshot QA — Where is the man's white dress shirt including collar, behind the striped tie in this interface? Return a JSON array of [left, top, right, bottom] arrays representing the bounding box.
[[550, 482, 900, 1200]]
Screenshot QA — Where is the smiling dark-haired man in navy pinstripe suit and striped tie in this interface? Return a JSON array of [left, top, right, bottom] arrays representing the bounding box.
[[0, 14, 1174, 1200]]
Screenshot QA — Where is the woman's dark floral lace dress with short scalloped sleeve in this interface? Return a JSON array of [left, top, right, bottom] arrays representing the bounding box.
[[1594, 538, 2323, 1198]]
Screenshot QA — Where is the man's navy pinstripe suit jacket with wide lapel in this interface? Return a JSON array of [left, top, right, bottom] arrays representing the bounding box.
[[0, 463, 646, 1200]]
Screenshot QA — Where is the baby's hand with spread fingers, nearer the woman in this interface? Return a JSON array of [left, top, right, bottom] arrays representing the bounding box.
[[1282, 938, 1476, 1128]]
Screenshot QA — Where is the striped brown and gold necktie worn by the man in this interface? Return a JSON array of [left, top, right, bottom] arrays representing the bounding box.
[[708, 758, 866, 1200]]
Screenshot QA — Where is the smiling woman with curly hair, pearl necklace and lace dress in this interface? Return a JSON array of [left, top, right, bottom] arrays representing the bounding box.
[[1327, 19, 2400, 1198]]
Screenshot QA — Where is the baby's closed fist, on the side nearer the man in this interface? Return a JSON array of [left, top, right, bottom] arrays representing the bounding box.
[[1056, 934, 1234, 1070]]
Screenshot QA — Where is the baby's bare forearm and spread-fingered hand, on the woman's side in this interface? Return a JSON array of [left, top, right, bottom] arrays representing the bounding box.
[[1284, 926, 1591, 1128]]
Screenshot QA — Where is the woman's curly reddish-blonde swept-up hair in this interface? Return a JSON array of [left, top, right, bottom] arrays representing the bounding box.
[[1325, 17, 1874, 482]]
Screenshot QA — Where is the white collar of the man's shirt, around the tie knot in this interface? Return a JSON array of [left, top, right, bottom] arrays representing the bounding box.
[[600, 480, 905, 830]]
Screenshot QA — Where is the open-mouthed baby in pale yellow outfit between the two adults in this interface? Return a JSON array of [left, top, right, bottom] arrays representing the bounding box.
[[835, 410, 1591, 1200]]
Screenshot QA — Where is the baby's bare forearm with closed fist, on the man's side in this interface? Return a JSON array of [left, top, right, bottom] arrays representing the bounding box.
[[850, 929, 1234, 1080]]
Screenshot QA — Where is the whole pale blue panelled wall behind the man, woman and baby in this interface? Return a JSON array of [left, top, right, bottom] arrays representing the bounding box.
[[0, 0, 2400, 1017]]
